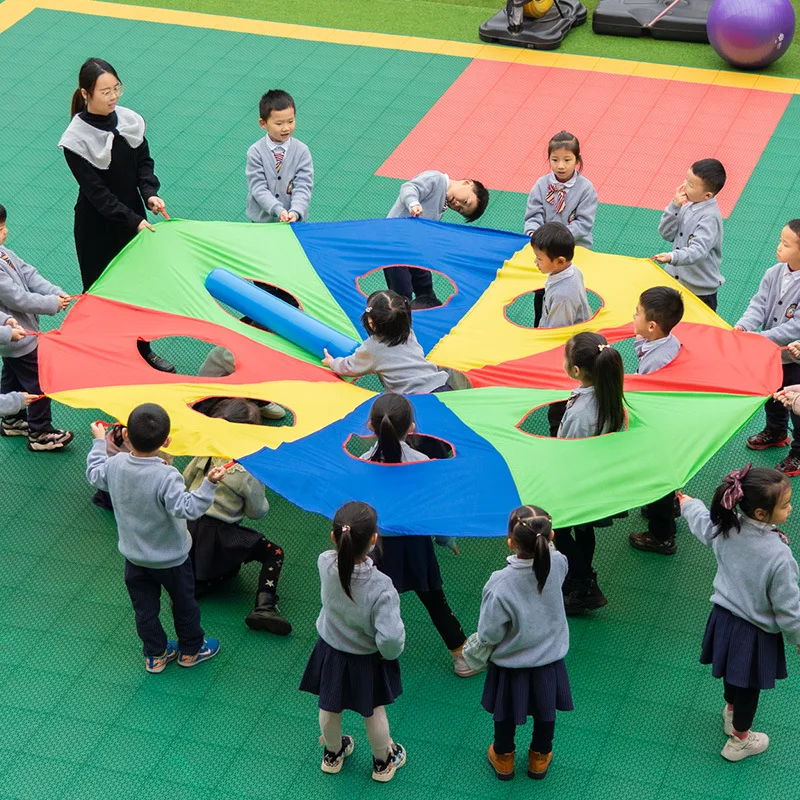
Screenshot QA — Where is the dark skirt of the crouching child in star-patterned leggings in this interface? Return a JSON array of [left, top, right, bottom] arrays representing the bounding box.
[[188, 514, 264, 581]]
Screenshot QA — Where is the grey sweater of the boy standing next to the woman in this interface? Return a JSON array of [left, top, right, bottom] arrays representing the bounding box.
[[245, 137, 314, 222]]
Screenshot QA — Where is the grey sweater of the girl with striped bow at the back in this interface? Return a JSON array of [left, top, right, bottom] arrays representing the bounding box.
[[524, 172, 597, 248]]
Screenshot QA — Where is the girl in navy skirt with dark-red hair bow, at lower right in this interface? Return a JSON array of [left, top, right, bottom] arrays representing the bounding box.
[[680, 464, 800, 761]]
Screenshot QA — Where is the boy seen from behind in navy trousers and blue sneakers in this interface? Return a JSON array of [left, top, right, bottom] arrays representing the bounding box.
[[86, 403, 225, 673]]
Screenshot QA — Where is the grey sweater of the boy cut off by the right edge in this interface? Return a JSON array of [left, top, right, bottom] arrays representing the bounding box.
[[736, 264, 800, 364]]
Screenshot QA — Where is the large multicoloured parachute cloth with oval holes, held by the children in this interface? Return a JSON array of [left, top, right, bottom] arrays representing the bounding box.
[[41, 219, 781, 536]]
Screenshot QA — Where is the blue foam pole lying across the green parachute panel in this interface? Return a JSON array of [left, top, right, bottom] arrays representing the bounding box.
[[205, 269, 361, 358]]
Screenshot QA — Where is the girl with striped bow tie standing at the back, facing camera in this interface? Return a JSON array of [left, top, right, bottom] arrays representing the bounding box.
[[525, 131, 597, 248]]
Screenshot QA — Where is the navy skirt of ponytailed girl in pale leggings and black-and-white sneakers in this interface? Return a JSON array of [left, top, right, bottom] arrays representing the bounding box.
[[300, 639, 403, 717]]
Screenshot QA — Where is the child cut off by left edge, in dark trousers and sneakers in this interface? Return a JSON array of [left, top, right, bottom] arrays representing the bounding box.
[[0, 205, 73, 452]]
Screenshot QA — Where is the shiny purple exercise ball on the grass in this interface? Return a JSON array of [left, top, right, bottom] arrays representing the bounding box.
[[707, 0, 794, 69]]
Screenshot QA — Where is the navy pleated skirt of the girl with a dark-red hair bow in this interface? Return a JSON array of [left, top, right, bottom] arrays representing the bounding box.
[[700, 605, 786, 689]]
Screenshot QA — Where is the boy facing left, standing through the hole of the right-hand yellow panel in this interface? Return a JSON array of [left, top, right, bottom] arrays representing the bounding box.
[[531, 222, 592, 436]]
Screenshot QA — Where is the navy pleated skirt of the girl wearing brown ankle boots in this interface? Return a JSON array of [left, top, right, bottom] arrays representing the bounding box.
[[481, 658, 573, 725]]
